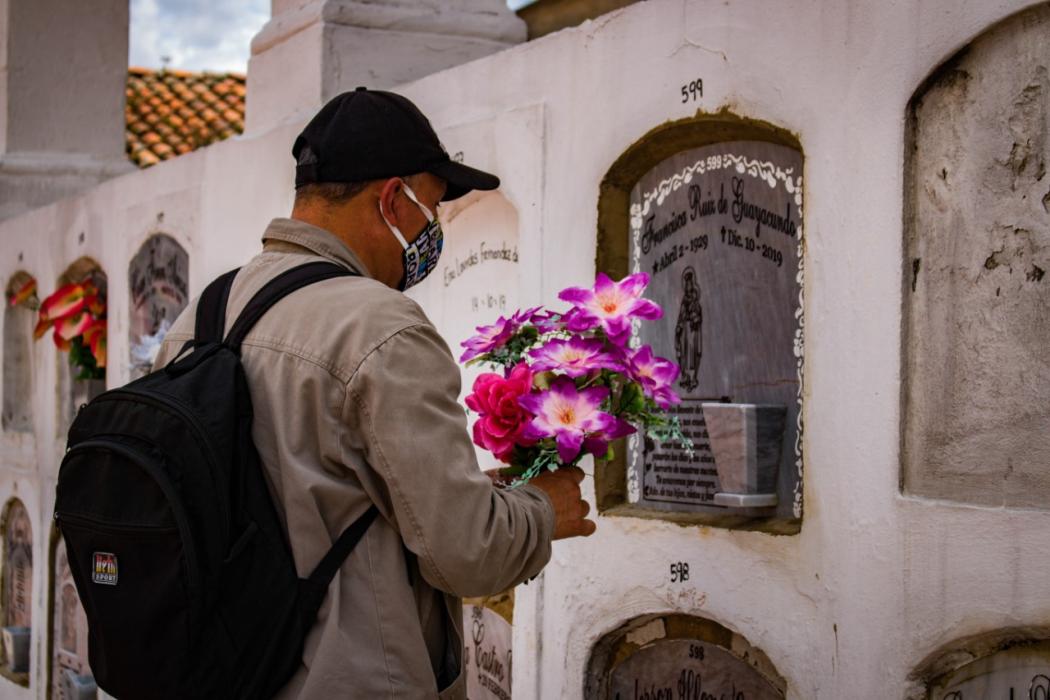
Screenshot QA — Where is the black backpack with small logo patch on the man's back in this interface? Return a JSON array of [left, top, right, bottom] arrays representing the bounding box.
[[55, 262, 377, 699]]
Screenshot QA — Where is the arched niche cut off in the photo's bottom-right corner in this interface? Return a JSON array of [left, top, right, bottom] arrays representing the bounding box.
[[906, 627, 1050, 700]]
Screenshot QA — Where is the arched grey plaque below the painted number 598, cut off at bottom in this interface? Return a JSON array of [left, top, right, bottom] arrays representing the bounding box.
[[609, 639, 784, 700]]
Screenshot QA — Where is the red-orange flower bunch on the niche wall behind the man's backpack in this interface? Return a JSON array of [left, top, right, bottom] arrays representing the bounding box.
[[34, 278, 106, 379]]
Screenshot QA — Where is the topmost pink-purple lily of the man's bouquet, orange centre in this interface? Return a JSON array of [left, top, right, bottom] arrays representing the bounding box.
[[558, 272, 664, 345]]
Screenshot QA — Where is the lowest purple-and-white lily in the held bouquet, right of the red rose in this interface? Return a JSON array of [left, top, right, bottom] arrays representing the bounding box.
[[518, 377, 633, 464]]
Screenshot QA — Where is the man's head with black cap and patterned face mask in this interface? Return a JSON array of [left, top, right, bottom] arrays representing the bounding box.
[[292, 88, 500, 287]]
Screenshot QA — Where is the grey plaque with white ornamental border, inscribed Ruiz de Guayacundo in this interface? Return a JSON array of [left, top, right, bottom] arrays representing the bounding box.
[[628, 142, 802, 519]]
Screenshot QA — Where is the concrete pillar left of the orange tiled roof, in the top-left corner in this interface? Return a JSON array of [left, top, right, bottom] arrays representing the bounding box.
[[0, 0, 133, 218]]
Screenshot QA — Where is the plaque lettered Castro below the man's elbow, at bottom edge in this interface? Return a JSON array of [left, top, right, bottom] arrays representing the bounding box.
[[463, 606, 512, 700]]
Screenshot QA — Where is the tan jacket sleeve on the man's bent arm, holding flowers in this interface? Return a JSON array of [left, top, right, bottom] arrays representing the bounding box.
[[344, 324, 554, 596]]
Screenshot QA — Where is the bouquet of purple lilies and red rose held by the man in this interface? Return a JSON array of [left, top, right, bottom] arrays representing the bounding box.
[[460, 273, 692, 486]]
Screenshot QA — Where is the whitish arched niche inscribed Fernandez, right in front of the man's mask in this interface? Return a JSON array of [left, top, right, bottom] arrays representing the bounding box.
[[410, 192, 521, 468]]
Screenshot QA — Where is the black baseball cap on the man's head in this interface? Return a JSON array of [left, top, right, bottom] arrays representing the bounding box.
[[292, 87, 500, 201]]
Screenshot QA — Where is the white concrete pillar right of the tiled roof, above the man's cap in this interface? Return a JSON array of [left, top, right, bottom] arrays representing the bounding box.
[[245, 0, 526, 133]]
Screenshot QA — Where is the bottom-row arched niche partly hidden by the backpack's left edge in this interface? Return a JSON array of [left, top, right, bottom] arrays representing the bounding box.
[[47, 530, 97, 700]]
